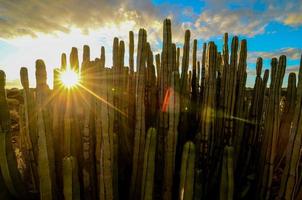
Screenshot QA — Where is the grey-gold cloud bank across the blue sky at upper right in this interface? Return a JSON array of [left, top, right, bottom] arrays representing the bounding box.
[[182, 0, 302, 39]]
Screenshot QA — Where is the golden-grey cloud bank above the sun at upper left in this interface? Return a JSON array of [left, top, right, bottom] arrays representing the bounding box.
[[0, 0, 163, 38]]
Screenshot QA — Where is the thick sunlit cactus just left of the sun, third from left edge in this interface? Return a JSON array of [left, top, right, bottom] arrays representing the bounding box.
[[36, 60, 57, 200]]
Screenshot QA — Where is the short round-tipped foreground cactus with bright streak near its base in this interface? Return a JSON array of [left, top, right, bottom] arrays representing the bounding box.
[[179, 141, 195, 200]]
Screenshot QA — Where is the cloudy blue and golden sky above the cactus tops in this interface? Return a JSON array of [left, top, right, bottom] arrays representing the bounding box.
[[0, 0, 302, 87]]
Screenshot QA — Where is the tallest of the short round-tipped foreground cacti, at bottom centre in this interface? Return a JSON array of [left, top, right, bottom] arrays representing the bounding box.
[[141, 128, 156, 200]]
